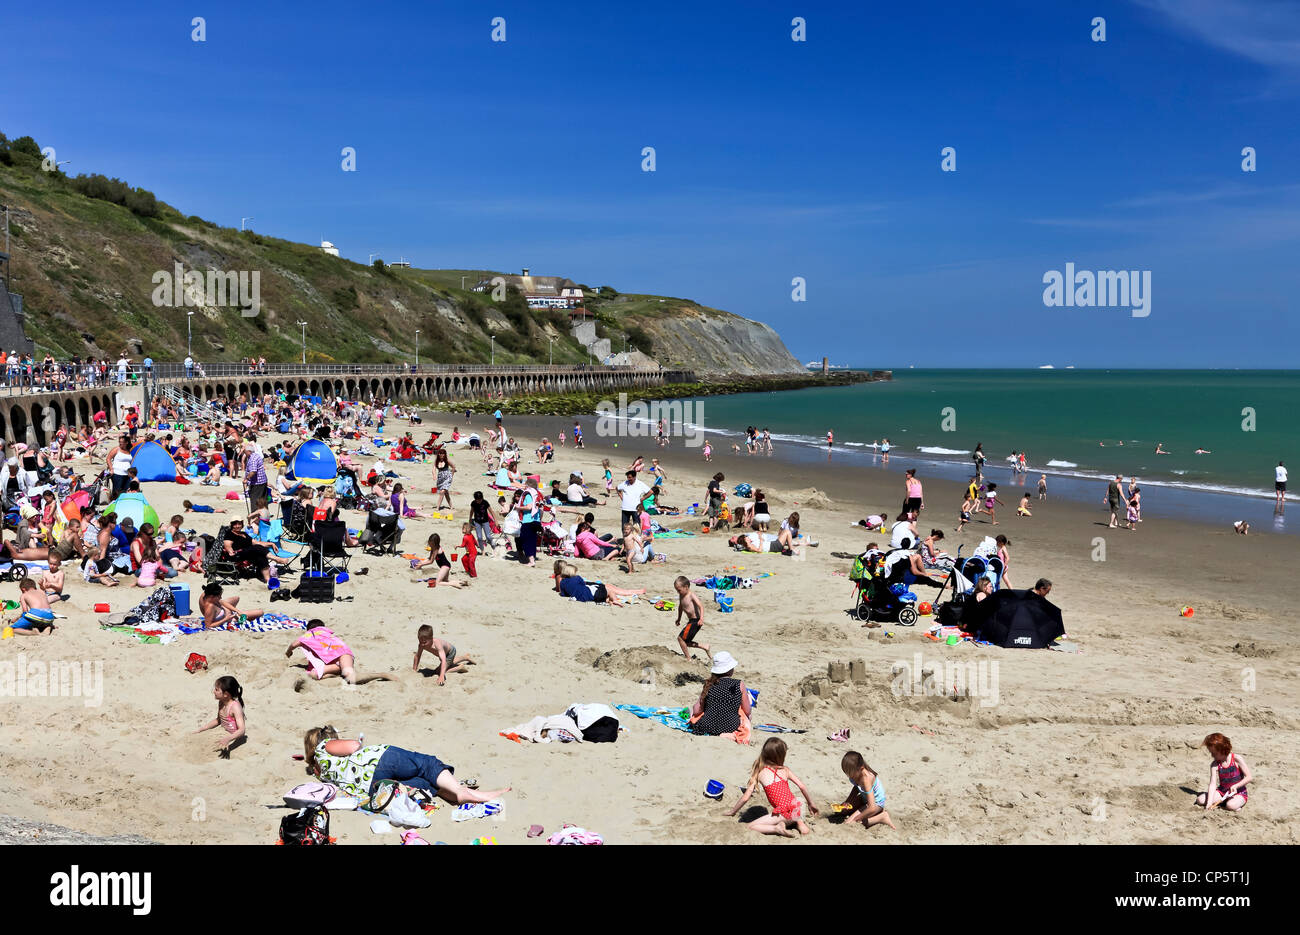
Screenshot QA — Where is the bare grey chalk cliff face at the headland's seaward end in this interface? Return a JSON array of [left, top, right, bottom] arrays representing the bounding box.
[[616, 304, 806, 376]]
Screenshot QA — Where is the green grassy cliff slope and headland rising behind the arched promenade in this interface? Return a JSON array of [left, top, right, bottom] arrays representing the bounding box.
[[0, 134, 797, 373]]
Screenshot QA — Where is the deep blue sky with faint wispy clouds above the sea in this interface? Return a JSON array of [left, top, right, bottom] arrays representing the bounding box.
[[0, 0, 1300, 368]]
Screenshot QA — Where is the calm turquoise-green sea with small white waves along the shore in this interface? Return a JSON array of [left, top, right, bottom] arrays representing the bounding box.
[[621, 368, 1300, 534]]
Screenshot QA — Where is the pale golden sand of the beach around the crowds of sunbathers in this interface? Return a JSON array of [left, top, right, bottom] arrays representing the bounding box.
[[0, 414, 1300, 845]]
